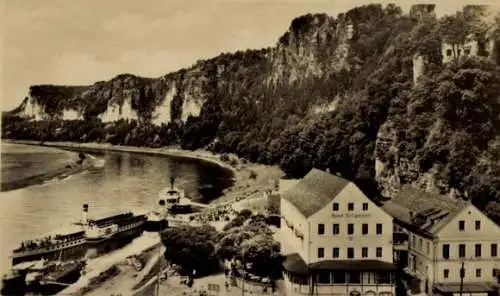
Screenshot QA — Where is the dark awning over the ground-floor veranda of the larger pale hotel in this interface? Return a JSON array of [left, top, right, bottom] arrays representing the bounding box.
[[309, 260, 396, 271]]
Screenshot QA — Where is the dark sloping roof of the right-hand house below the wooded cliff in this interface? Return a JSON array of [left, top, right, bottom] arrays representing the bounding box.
[[382, 185, 470, 237]]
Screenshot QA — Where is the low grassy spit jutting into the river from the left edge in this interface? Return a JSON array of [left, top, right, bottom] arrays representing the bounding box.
[[0, 141, 93, 192]]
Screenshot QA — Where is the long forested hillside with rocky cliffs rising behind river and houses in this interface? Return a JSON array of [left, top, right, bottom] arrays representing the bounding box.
[[2, 4, 500, 222]]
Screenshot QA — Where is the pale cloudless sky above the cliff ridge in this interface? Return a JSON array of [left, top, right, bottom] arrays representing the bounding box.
[[0, 0, 494, 110]]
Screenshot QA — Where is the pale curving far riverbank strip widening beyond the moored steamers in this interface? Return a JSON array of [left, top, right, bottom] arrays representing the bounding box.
[[5, 140, 284, 203]]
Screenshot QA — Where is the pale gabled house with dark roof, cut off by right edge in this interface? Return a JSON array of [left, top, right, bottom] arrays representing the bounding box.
[[382, 185, 500, 295]]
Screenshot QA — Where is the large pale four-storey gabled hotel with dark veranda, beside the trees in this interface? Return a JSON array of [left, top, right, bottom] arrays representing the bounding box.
[[280, 169, 395, 296]]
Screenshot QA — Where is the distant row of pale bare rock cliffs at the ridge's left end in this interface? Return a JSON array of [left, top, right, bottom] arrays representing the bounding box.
[[10, 75, 208, 125]]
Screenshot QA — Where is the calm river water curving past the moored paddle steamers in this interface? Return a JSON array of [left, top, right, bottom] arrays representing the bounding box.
[[0, 143, 233, 273]]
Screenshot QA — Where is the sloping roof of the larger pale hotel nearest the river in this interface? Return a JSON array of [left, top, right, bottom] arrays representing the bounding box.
[[283, 169, 350, 218]]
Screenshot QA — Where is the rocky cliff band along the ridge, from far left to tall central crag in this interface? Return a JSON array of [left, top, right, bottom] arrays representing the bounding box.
[[6, 10, 355, 125]]
